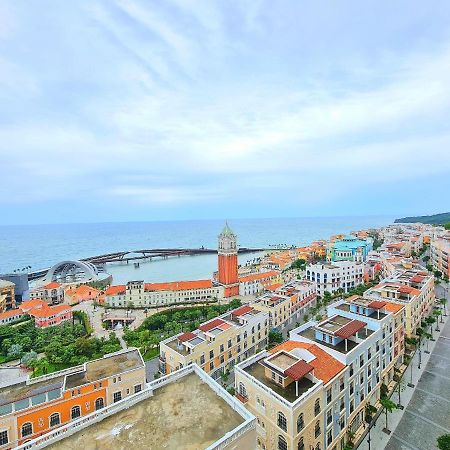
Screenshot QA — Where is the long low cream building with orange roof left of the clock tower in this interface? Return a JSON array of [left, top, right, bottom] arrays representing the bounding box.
[[105, 280, 223, 308]]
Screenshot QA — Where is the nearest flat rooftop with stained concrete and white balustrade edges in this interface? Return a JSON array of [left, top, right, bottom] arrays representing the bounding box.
[[14, 364, 256, 450]]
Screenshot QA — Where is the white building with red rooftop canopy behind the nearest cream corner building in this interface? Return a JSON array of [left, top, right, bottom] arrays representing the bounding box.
[[290, 299, 398, 450]]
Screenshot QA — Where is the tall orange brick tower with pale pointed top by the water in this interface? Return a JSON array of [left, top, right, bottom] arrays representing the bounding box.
[[217, 223, 239, 298]]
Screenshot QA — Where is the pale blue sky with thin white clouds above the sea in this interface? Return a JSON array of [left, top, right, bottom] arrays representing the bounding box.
[[0, 0, 450, 224]]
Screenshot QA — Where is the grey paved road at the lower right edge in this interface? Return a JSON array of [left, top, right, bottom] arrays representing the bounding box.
[[386, 320, 450, 450]]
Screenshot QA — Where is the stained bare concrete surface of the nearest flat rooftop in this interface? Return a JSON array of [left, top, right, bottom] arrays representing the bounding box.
[[48, 373, 245, 450]]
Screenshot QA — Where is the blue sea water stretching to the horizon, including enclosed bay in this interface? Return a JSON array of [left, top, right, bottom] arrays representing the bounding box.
[[0, 216, 395, 284]]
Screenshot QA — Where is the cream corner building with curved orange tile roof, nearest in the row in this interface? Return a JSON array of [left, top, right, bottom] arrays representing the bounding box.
[[235, 341, 345, 450]]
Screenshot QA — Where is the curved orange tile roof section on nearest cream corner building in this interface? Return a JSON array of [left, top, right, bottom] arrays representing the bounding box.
[[269, 341, 345, 383]]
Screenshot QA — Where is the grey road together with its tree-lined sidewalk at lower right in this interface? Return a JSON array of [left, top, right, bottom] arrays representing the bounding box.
[[358, 317, 450, 450]]
